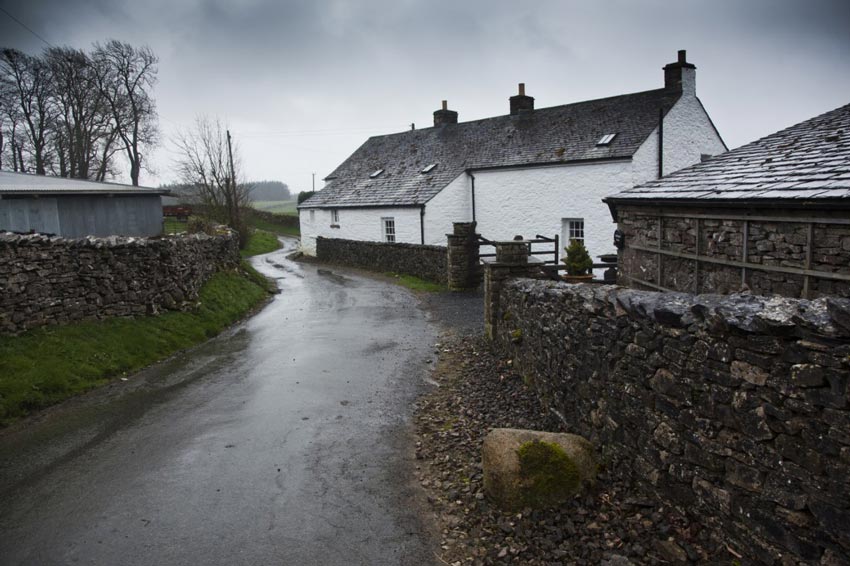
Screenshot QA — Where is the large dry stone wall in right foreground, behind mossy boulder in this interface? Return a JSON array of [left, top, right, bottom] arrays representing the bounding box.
[[492, 279, 850, 564]]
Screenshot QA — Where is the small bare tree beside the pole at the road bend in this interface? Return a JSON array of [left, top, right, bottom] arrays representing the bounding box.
[[174, 116, 251, 245]]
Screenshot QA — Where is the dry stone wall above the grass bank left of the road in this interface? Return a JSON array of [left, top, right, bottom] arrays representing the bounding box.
[[0, 232, 239, 334]]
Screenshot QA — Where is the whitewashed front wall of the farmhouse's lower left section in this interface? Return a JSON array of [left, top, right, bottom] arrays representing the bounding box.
[[298, 208, 422, 255]]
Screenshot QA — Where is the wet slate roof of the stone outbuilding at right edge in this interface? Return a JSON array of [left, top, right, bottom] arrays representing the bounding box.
[[605, 104, 850, 205]]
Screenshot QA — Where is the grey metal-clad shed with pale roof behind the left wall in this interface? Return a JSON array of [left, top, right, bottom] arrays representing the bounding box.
[[0, 171, 168, 238]]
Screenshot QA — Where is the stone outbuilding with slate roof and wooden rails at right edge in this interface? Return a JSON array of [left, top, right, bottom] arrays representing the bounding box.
[[605, 101, 850, 298]]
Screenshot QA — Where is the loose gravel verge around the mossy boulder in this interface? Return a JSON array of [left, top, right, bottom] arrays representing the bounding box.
[[415, 333, 736, 566]]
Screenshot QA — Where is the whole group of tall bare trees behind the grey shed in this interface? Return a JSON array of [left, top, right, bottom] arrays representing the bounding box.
[[0, 39, 159, 186]]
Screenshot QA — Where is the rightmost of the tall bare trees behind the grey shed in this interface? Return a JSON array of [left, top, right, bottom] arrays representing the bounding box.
[[92, 39, 159, 186]]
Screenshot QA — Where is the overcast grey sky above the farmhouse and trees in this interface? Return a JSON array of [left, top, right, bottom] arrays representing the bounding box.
[[0, 0, 850, 191]]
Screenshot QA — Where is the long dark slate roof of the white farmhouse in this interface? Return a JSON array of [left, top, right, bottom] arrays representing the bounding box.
[[299, 89, 680, 208]]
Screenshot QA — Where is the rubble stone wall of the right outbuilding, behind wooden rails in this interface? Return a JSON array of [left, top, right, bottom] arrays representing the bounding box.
[[617, 206, 850, 298]]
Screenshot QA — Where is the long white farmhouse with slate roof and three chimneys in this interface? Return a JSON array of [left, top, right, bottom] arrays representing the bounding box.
[[299, 51, 727, 262]]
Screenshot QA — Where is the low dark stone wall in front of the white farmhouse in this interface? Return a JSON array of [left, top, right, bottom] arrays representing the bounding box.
[[316, 236, 448, 285]]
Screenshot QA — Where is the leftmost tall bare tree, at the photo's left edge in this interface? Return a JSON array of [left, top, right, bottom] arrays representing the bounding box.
[[0, 48, 53, 175]]
